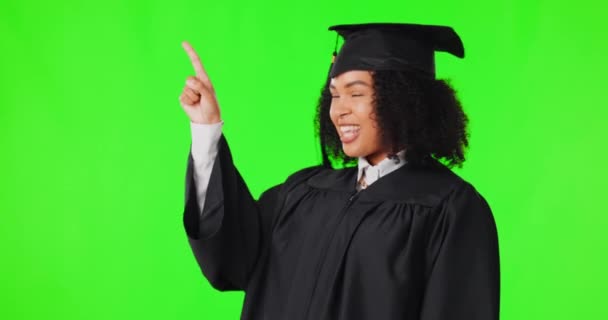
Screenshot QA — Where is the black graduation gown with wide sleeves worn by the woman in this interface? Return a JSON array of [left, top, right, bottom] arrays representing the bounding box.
[[184, 136, 500, 320]]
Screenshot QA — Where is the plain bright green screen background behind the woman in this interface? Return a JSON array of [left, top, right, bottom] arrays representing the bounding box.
[[0, 0, 608, 320]]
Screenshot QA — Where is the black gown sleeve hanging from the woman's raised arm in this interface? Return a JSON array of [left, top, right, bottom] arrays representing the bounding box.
[[183, 135, 280, 291]]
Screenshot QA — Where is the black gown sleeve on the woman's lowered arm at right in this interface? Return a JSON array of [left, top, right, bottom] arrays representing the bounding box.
[[421, 183, 500, 320]]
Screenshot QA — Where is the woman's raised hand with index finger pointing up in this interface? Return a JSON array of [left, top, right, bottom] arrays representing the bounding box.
[[179, 41, 221, 124]]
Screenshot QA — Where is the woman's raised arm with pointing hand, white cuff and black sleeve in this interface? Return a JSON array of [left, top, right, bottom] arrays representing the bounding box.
[[180, 42, 278, 290]]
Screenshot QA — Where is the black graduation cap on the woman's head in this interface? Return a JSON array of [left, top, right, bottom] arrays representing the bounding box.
[[329, 23, 464, 78]]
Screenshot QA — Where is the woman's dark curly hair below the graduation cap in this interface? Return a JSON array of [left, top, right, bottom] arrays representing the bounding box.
[[315, 71, 469, 168]]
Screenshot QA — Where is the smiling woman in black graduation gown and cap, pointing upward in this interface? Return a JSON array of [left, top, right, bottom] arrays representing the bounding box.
[[180, 24, 500, 320]]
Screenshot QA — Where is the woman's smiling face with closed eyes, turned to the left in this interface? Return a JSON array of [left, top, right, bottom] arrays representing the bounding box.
[[329, 70, 388, 165]]
